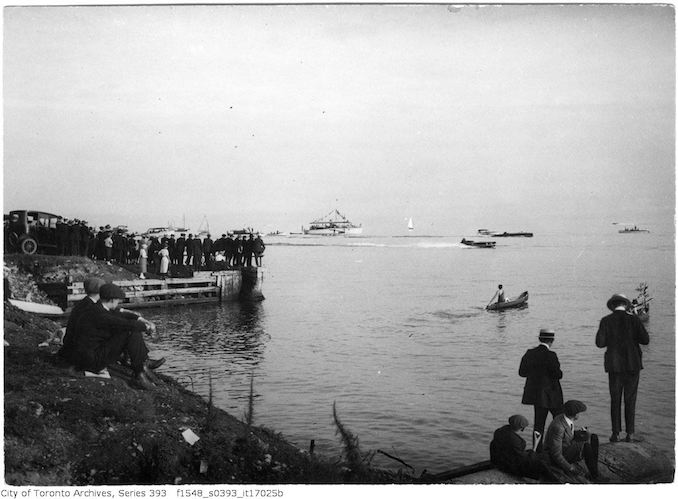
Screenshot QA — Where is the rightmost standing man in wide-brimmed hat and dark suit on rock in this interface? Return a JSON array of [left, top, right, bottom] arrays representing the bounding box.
[[596, 294, 650, 442]]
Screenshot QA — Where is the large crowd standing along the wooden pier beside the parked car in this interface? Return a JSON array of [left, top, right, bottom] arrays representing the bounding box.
[[51, 217, 266, 278]]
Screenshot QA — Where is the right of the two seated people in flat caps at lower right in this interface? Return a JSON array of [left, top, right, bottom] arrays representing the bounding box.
[[544, 400, 599, 480]]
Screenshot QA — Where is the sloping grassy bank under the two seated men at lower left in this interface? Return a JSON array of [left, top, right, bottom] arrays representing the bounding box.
[[4, 257, 409, 485]]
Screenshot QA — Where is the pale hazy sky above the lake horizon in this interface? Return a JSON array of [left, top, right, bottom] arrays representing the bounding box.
[[3, 4, 676, 235]]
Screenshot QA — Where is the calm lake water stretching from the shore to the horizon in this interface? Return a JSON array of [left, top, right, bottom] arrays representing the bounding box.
[[144, 228, 675, 473]]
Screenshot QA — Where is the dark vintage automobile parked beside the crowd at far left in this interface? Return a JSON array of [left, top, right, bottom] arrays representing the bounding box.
[[4, 210, 59, 255]]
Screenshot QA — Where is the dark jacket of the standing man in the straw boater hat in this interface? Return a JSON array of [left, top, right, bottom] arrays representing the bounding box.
[[518, 345, 563, 409]]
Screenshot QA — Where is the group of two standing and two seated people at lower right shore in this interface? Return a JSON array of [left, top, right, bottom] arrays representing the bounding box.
[[490, 294, 650, 482]]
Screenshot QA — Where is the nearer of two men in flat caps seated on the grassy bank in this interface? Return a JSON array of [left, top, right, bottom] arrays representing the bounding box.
[[75, 284, 165, 389]]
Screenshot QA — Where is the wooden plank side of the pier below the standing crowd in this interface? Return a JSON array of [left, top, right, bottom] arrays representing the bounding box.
[[67, 267, 264, 309]]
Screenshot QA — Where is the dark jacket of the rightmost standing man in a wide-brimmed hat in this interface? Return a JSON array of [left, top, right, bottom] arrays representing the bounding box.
[[596, 310, 650, 373]]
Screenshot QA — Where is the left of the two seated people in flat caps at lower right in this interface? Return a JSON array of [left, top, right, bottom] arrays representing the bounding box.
[[490, 414, 555, 481]]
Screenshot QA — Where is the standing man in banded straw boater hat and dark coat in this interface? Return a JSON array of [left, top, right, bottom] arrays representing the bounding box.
[[518, 329, 563, 450]]
